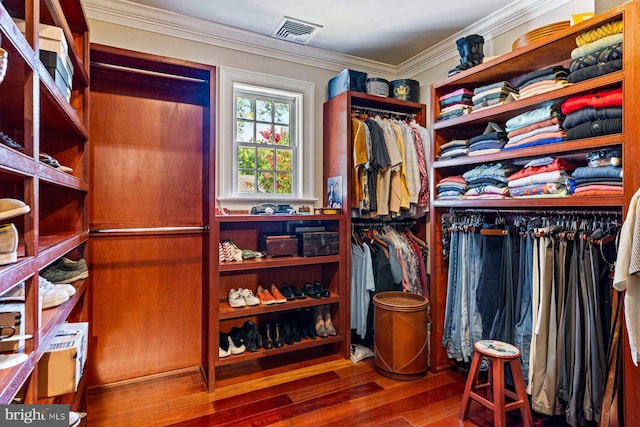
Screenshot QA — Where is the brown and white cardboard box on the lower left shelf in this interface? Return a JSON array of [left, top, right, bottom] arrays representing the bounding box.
[[38, 322, 89, 397]]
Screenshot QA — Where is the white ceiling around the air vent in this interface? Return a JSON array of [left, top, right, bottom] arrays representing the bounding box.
[[90, 0, 518, 66]]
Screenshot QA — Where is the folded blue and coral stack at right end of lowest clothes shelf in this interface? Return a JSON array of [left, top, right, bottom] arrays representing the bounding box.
[[572, 148, 622, 196]]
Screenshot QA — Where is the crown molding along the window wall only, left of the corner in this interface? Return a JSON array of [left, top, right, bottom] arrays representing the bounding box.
[[83, 0, 396, 77]]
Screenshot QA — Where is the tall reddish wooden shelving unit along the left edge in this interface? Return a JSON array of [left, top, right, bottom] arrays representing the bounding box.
[[0, 0, 90, 410]]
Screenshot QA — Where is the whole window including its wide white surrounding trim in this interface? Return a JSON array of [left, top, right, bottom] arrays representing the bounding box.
[[217, 69, 313, 205]]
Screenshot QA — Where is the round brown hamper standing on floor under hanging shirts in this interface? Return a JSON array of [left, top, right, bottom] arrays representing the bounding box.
[[373, 291, 429, 380]]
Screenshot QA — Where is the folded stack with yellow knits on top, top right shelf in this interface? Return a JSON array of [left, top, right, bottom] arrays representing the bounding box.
[[568, 21, 624, 83]]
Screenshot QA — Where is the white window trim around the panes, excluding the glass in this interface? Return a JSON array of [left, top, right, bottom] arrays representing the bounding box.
[[216, 67, 316, 209]]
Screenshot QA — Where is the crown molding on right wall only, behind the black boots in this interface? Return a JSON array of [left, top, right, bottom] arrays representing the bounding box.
[[398, 0, 571, 76]]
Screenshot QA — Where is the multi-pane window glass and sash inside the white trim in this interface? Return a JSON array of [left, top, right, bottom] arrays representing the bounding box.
[[234, 85, 297, 197]]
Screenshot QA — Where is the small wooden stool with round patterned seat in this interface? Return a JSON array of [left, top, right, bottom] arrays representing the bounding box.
[[458, 340, 533, 427]]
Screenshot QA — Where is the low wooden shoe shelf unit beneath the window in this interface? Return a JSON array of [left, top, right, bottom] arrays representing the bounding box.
[[203, 214, 350, 391]]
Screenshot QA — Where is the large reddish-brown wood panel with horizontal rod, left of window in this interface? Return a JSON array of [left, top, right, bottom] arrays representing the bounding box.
[[89, 61, 208, 385]]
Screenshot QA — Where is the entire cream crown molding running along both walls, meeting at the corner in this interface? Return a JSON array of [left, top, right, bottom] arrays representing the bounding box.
[[83, 0, 570, 80]]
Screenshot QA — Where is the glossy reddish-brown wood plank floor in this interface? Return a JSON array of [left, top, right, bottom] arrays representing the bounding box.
[[88, 355, 544, 427]]
